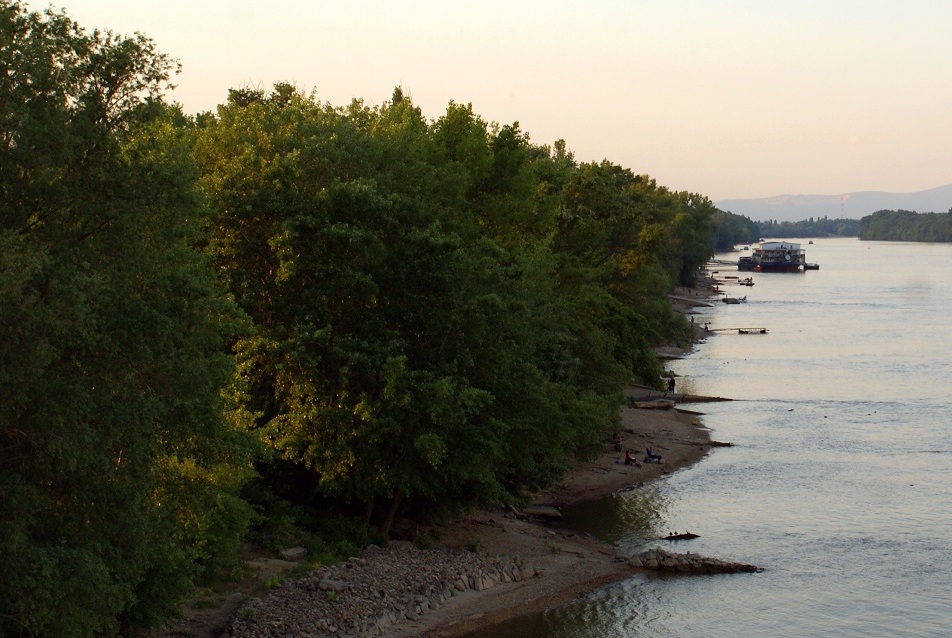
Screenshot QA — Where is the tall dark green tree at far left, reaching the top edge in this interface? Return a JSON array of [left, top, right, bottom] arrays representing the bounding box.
[[0, 0, 248, 636]]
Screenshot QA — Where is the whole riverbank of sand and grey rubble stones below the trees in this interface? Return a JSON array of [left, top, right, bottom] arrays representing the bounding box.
[[165, 288, 711, 638]]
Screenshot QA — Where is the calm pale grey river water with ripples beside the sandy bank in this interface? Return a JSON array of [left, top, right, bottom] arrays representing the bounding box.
[[464, 238, 952, 638]]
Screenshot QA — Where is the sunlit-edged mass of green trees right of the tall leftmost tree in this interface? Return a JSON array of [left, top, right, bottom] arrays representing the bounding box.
[[196, 85, 713, 530]]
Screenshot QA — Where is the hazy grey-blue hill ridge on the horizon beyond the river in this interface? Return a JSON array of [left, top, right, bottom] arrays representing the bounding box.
[[714, 184, 952, 222]]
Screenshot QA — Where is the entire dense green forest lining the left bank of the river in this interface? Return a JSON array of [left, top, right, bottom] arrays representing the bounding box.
[[0, 0, 718, 637]]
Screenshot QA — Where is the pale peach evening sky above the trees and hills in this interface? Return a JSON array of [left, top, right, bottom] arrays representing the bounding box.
[[41, 0, 952, 201]]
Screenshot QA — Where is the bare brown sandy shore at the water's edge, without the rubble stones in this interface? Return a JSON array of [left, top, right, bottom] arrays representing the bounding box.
[[387, 288, 711, 638]]
